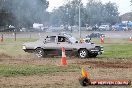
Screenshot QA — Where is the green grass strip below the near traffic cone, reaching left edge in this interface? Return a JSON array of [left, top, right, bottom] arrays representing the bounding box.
[[0, 64, 80, 77]]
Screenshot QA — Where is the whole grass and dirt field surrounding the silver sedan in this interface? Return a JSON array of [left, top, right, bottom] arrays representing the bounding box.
[[0, 38, 132, 88]]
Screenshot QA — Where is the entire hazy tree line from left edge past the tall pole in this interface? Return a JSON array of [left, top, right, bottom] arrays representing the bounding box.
[[0, 0, 120, 27]]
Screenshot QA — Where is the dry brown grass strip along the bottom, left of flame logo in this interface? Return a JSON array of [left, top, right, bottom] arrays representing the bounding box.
[[0, 72, 80, 85]]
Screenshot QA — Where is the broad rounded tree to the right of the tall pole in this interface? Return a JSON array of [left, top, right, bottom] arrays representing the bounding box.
[[86, 0, 119, 25]]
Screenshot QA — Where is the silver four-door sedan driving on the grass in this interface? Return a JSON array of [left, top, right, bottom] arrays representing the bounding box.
[[22, 33, 103, 58]]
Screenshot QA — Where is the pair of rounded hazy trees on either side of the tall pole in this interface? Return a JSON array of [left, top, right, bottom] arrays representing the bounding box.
[[50, 0, 120, 26]]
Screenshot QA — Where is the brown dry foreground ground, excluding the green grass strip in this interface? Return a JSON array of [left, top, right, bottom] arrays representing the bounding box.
[[0, 58, 132, 88]]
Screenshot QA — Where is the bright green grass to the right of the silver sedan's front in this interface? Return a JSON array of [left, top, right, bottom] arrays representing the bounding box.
[[92, 38, 132, 59]]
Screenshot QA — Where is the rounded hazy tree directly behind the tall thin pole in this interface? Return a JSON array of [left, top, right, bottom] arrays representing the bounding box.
[[51, 0, 84, 25]]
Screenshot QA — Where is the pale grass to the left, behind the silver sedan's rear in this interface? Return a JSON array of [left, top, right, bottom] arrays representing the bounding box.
[[0, 38, 36, 56]]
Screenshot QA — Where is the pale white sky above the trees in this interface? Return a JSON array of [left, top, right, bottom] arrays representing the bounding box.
[[48, 0, 132, 15]]
